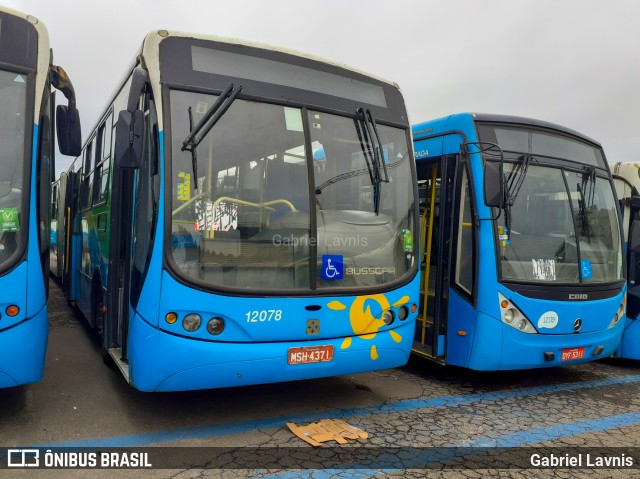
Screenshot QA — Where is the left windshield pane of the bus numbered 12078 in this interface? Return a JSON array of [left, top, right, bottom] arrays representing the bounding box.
[[171, 91, 310, 290]]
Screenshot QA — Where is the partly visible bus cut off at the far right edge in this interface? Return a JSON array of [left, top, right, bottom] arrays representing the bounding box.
[[612, 163, 640, 360]]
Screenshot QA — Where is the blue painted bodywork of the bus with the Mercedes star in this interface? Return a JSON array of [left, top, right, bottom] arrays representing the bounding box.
[[413, 113, 624, 370]]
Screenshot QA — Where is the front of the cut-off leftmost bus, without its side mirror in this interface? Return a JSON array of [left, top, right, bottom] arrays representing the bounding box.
[[0, 10, 48, 387]]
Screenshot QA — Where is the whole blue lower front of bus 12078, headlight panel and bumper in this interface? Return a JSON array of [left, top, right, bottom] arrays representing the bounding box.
[[128, 272, 419, 391]]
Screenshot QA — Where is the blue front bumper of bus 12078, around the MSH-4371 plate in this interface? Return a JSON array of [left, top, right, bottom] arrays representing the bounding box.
[[129, 315, 414, 391]]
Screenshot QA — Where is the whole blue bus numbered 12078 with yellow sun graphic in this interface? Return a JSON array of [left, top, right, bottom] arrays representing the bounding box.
[[57, 30, 419, 391]]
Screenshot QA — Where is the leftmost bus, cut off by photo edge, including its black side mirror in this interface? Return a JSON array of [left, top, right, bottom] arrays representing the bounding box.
[[0, 7, 81, 388]]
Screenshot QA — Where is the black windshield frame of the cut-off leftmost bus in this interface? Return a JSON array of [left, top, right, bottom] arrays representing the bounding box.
[[0, 62, 35, 275]]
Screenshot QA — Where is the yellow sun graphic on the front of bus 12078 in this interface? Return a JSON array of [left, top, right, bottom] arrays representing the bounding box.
[[327, 294, 409, 361]]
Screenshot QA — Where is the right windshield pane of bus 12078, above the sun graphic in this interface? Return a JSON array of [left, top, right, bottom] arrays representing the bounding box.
[[309, 111, 413, 287]]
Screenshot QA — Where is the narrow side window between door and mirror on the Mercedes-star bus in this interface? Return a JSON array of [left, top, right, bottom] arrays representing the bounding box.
[[455, 167, 476, 297]]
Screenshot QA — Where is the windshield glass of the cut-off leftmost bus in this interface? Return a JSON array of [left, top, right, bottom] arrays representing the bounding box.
[[0, 70, 27, 268]]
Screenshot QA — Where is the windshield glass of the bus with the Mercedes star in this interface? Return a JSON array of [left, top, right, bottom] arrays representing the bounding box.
[[497, 163, 622, 284]]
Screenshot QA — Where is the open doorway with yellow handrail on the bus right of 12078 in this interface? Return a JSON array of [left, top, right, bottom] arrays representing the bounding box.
[[412, 155, 459, 362]]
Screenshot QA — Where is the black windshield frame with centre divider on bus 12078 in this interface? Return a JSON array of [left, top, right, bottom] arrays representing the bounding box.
[[160, 83, 419, 297]]
